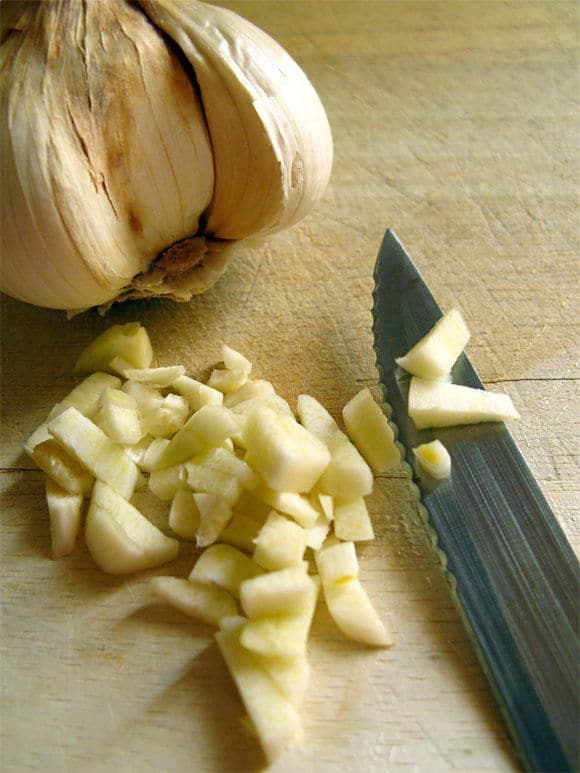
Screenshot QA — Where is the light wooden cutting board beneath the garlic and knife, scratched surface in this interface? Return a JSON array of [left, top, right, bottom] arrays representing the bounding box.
[[0, 0, 580, 773]]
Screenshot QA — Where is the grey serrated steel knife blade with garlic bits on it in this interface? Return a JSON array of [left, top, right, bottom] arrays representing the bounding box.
[[373, 229, 580, 772]]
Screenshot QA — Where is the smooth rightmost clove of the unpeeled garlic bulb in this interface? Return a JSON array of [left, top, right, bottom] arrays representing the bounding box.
[[140, 0, 332, 239]]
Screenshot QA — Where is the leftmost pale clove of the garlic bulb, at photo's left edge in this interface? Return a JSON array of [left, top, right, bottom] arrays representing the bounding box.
[[0, 14, 133, 308]]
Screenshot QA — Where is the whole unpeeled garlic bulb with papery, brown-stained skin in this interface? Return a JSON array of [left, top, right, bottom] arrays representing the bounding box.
[[1, 0, 332, 311]]
